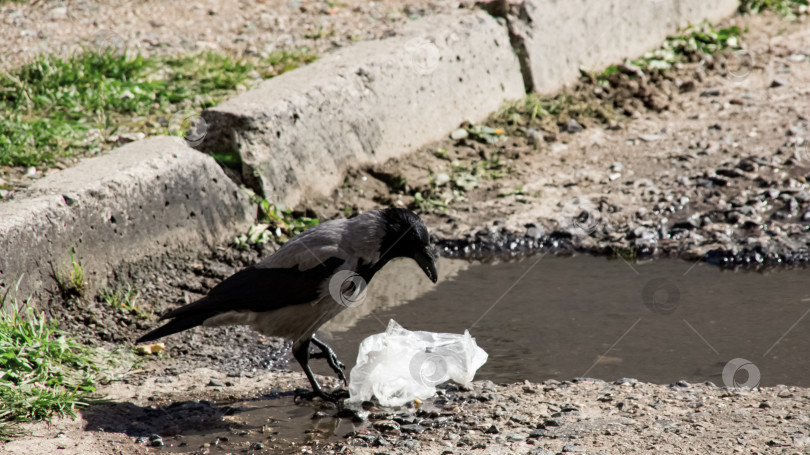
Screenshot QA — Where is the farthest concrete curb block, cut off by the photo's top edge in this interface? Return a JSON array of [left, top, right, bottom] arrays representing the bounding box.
[[502, 0, 739, 93]]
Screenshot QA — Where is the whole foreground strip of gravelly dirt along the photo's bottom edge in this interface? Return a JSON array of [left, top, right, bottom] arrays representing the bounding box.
[[0, 369, 810, 455]]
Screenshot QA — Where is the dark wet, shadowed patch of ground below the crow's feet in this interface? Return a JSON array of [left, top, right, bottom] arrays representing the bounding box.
[[82, 392, 354, 454]]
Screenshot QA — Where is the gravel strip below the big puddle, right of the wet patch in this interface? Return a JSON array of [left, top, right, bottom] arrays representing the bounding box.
[[324, 379, 810, 454]]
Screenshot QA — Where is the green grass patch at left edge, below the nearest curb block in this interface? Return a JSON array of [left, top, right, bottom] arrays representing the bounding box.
[[0, 282, 129, 440]]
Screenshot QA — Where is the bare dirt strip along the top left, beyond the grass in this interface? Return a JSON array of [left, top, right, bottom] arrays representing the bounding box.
[[0, 0, 458, 70]]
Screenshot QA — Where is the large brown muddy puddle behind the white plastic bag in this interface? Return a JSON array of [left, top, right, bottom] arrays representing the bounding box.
[[322, 255, 810, 387]]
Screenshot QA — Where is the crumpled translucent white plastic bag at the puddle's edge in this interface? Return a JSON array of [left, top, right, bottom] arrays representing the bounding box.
[[348, 319, 488, 406]]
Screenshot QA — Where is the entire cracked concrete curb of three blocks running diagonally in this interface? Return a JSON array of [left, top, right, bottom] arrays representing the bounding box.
[[0, 0, 737, 306]]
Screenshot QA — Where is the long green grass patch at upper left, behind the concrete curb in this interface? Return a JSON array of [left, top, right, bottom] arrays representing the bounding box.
[[0, 49, 316, 166]]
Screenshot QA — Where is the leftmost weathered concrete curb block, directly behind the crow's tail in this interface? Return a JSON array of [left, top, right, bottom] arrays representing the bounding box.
[[0, 137, 256, 303]]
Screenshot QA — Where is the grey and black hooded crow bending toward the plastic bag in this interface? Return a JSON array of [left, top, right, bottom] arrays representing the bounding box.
[[138, 208, 438, 401]]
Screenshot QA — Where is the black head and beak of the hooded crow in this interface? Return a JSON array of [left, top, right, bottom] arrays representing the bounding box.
[[380, 208, 438, 283]]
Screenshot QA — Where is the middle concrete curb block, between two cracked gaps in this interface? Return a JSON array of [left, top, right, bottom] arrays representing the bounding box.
[[203, 10, 525, 206]]
